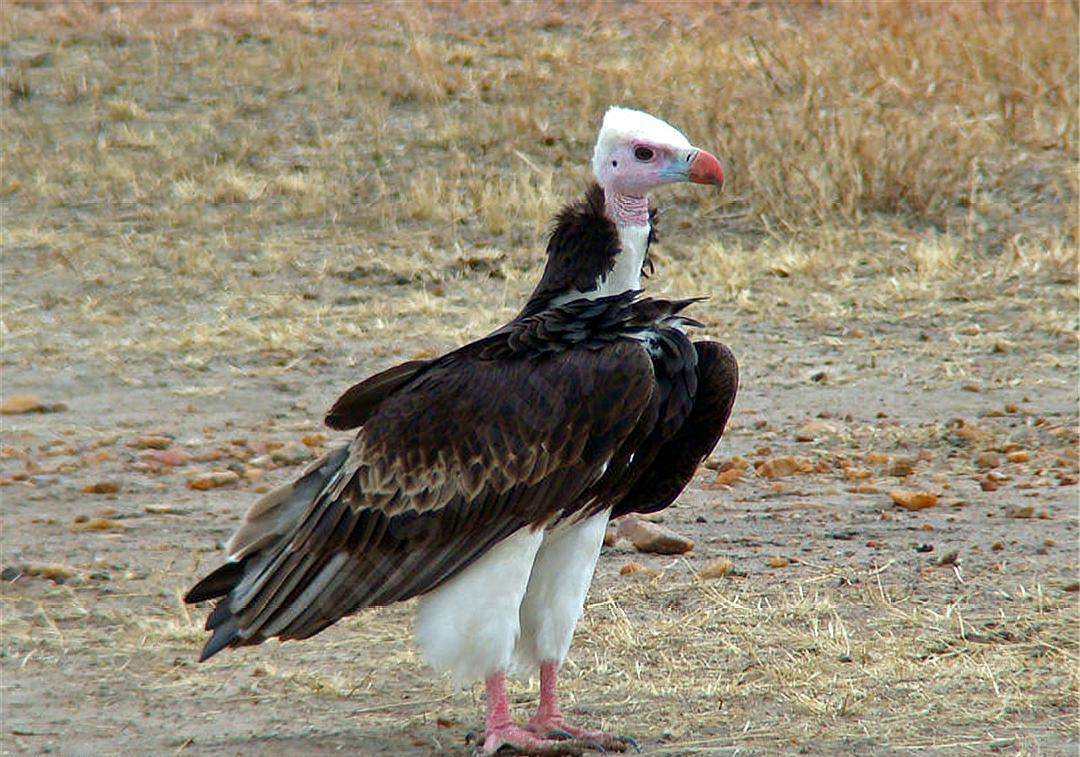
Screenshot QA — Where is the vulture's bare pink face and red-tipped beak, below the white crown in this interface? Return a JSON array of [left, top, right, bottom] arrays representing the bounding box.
[[597, 138, 724, 197]]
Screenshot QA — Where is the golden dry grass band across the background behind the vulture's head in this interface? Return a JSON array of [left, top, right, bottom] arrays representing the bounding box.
[[0, 3, 1078, 367]]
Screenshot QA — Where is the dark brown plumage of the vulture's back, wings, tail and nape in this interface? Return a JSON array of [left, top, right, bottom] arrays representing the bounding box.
[[186, 186, 738, 659]]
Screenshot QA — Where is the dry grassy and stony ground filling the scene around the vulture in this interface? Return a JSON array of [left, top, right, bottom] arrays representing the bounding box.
[[0, 5, 1080, 755]]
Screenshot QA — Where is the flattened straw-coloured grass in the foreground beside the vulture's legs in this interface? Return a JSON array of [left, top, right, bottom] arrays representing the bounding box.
[[4, 562, 1080, 755]]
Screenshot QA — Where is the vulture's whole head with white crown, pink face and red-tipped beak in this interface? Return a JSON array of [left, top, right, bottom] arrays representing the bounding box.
[[593, 108, 724, 198]]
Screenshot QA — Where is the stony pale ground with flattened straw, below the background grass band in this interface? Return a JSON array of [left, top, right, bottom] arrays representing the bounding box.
[[0, 287, 1077, 754]]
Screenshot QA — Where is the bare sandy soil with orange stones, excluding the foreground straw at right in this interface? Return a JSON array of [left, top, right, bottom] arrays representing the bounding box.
[[0, 291, 1077, 754]]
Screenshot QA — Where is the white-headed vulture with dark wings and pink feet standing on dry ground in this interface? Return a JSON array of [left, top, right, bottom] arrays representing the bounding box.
[[185, 107, 739, 755]]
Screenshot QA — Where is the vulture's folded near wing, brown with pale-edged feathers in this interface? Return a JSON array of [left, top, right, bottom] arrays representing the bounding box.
[[187, 341, 657, 659]]
